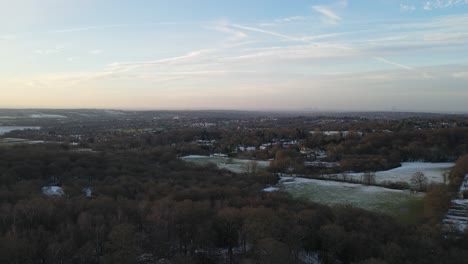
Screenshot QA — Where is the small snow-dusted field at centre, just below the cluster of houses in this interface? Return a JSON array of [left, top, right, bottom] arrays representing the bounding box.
[[181, 155, 270, 173]]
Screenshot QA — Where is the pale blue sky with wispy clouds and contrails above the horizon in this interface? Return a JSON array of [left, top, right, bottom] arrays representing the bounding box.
[[0, 0, 468, 112]]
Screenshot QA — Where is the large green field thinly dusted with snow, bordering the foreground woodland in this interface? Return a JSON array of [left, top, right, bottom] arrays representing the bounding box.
[[280, 177, 424, 221]]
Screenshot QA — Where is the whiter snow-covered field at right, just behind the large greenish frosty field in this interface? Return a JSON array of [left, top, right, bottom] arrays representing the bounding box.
[[323, 162, 455, 183]]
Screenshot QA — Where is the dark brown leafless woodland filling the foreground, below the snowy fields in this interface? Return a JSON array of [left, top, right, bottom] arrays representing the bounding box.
[[0, 145, 468, 264]]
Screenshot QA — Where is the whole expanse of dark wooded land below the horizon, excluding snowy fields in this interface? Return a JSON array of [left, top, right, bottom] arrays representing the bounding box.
[[0, 114, 468, 264]]
